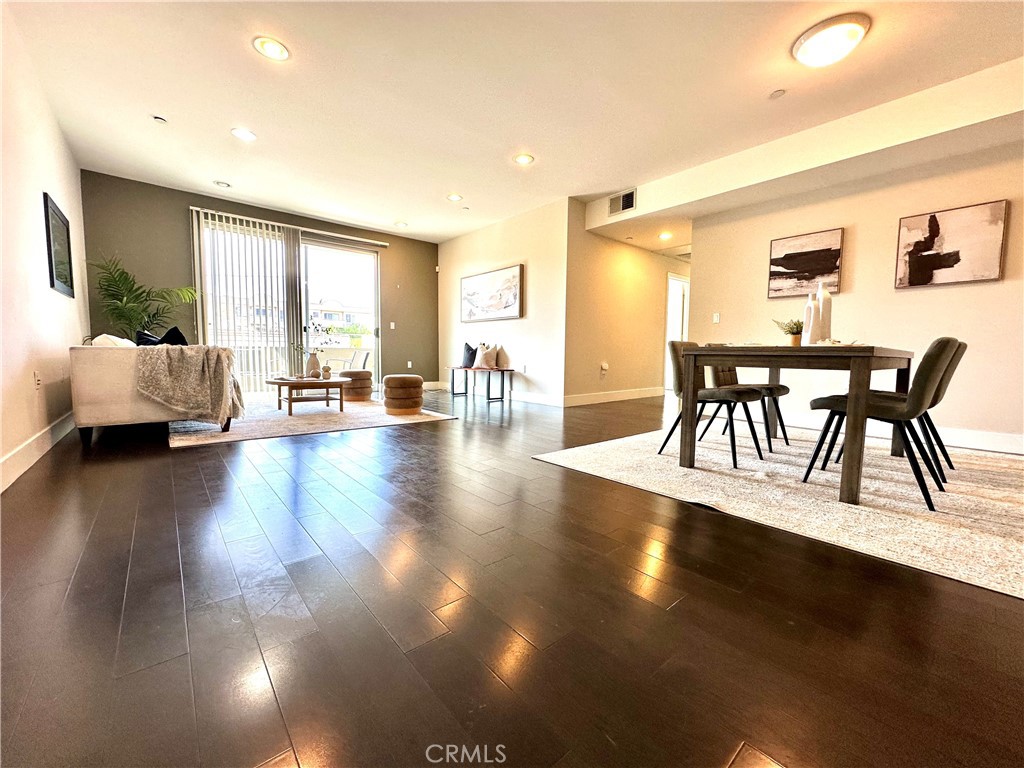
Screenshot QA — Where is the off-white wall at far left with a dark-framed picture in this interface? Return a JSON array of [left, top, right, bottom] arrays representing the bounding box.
[[0, 5, 89, 488]]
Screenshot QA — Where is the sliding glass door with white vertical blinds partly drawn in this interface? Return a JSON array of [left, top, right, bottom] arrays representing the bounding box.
[[193, 209, 387, 392]]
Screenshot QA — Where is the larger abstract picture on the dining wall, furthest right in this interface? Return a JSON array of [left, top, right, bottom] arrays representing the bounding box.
[[896, 200, 1008, 288]]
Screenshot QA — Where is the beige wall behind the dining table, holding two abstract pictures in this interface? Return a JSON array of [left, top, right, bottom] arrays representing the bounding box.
[[690, 143, 1024, 452]]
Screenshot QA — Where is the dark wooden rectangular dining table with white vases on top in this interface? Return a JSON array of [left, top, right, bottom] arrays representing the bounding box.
[[679, 344, 913, 504]]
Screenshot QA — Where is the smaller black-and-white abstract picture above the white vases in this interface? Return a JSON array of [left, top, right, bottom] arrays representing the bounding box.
[[768, 227, 843, 299]]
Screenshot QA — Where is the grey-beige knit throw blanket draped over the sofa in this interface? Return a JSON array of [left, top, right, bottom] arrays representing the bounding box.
[[135, 344, 245, 424]]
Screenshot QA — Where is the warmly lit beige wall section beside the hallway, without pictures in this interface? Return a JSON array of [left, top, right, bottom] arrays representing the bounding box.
[[565, 200, 689, 406]]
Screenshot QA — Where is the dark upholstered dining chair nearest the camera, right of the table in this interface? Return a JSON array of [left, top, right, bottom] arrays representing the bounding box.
[[803, 336, 961, 512]]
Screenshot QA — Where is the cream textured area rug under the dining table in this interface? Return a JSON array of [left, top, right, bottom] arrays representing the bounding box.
[[534, 424, 1024, 597]]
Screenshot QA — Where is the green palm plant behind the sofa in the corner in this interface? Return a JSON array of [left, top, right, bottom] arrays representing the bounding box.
[[89, 256, 199, 340]]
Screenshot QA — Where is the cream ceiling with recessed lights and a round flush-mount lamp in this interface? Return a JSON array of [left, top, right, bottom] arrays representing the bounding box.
[[8, 2, 1024, 248]]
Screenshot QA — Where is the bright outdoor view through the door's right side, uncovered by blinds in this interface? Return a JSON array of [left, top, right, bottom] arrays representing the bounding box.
[[302, 242, 377, 379]]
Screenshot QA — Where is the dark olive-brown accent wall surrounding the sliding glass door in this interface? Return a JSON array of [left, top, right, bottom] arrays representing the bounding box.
[[75, 171, 438, 381]]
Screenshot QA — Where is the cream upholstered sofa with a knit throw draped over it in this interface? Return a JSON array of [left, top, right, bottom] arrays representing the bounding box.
[[71, 346, 231, 447]]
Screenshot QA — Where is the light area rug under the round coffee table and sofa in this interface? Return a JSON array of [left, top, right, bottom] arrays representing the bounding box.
[[168, 397, 455, 449]]
